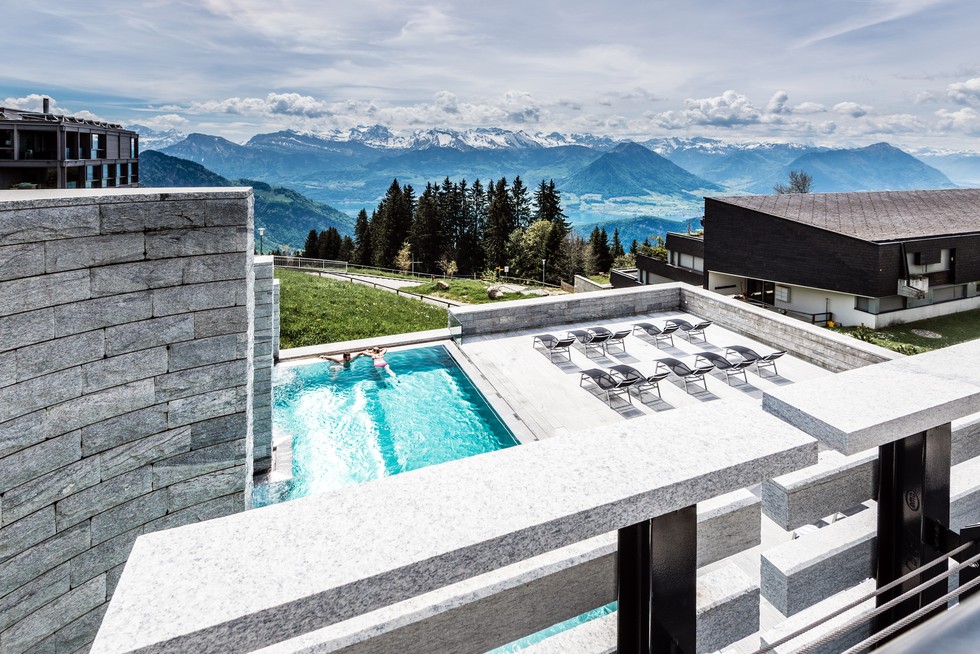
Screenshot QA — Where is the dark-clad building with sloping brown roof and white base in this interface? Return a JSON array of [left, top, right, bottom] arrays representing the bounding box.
[[704, 189, 980, 327]]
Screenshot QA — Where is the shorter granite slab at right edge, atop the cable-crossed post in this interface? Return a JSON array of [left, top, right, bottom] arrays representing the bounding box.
[[762, 340, 980, 455]]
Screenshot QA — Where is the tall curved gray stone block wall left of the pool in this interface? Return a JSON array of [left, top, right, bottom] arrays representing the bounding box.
[[0, 189, 253, 654]]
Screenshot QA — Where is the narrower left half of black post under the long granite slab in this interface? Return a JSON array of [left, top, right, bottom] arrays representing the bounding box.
[[616, 520, 652, 654]]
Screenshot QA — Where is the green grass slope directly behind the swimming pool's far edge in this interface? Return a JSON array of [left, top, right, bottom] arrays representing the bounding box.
[[276, 268, 447, 348]]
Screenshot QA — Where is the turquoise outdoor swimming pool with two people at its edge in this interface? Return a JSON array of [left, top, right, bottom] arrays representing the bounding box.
[[252, 345, 518, 507]]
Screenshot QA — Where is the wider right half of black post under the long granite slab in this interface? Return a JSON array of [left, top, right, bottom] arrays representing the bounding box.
[[651, 505, 698, 654]]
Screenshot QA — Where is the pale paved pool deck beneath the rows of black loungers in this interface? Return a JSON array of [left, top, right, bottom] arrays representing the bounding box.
[[462, 311, 832, 439]]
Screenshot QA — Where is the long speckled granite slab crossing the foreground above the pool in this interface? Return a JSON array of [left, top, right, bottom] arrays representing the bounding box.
[[93, 400, 817, 652]]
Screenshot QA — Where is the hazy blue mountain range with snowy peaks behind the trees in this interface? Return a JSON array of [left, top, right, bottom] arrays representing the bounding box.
[[136, 125, 980, 249]]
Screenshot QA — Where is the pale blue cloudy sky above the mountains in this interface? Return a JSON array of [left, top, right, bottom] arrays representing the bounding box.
[[7, 0, 980, 151]]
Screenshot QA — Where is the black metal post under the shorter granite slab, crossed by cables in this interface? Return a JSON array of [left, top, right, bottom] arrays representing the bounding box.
[[875, 424, 951, 642]]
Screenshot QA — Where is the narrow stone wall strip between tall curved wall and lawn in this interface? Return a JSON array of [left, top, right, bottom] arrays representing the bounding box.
[[252, 256, 279, 475]]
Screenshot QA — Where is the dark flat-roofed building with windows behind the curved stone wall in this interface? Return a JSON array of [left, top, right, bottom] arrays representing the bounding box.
[[0, 100, 139, 189]]
